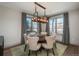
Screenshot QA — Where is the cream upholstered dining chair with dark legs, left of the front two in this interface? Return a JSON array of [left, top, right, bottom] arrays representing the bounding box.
[[27, 37, 41, 55]]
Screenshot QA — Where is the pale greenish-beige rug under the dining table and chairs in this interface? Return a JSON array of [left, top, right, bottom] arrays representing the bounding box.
[[10, 43, 67, 56]]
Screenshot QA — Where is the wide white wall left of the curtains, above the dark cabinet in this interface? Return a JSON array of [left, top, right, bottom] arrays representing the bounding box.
[[0, 6, 21, 48]]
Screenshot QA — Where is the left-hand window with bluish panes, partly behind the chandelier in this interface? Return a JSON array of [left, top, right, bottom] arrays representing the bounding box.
[[26, 17, 38, 32]]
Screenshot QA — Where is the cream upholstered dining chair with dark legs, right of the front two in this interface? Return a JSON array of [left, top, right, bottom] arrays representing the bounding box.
[[42, 36, 55, 55]]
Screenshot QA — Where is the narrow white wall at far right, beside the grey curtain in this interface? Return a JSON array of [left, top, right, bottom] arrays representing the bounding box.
[[69, 10, 79, 45]]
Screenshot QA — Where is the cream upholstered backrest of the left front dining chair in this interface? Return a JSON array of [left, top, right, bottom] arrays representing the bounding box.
[[28, 37, 39, 50]]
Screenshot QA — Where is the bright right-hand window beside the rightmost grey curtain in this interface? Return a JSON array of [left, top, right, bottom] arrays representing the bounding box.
[[49, 15, 63, 34]]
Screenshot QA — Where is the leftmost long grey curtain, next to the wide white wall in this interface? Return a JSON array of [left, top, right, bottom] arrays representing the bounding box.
[[21, 13, 27, 44]]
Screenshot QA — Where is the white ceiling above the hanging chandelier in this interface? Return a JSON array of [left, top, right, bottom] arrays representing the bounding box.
[[0, 2, 79, 16]]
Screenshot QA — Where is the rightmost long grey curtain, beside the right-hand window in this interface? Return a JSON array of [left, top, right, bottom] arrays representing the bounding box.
[[63, 13, 70, 44]]
